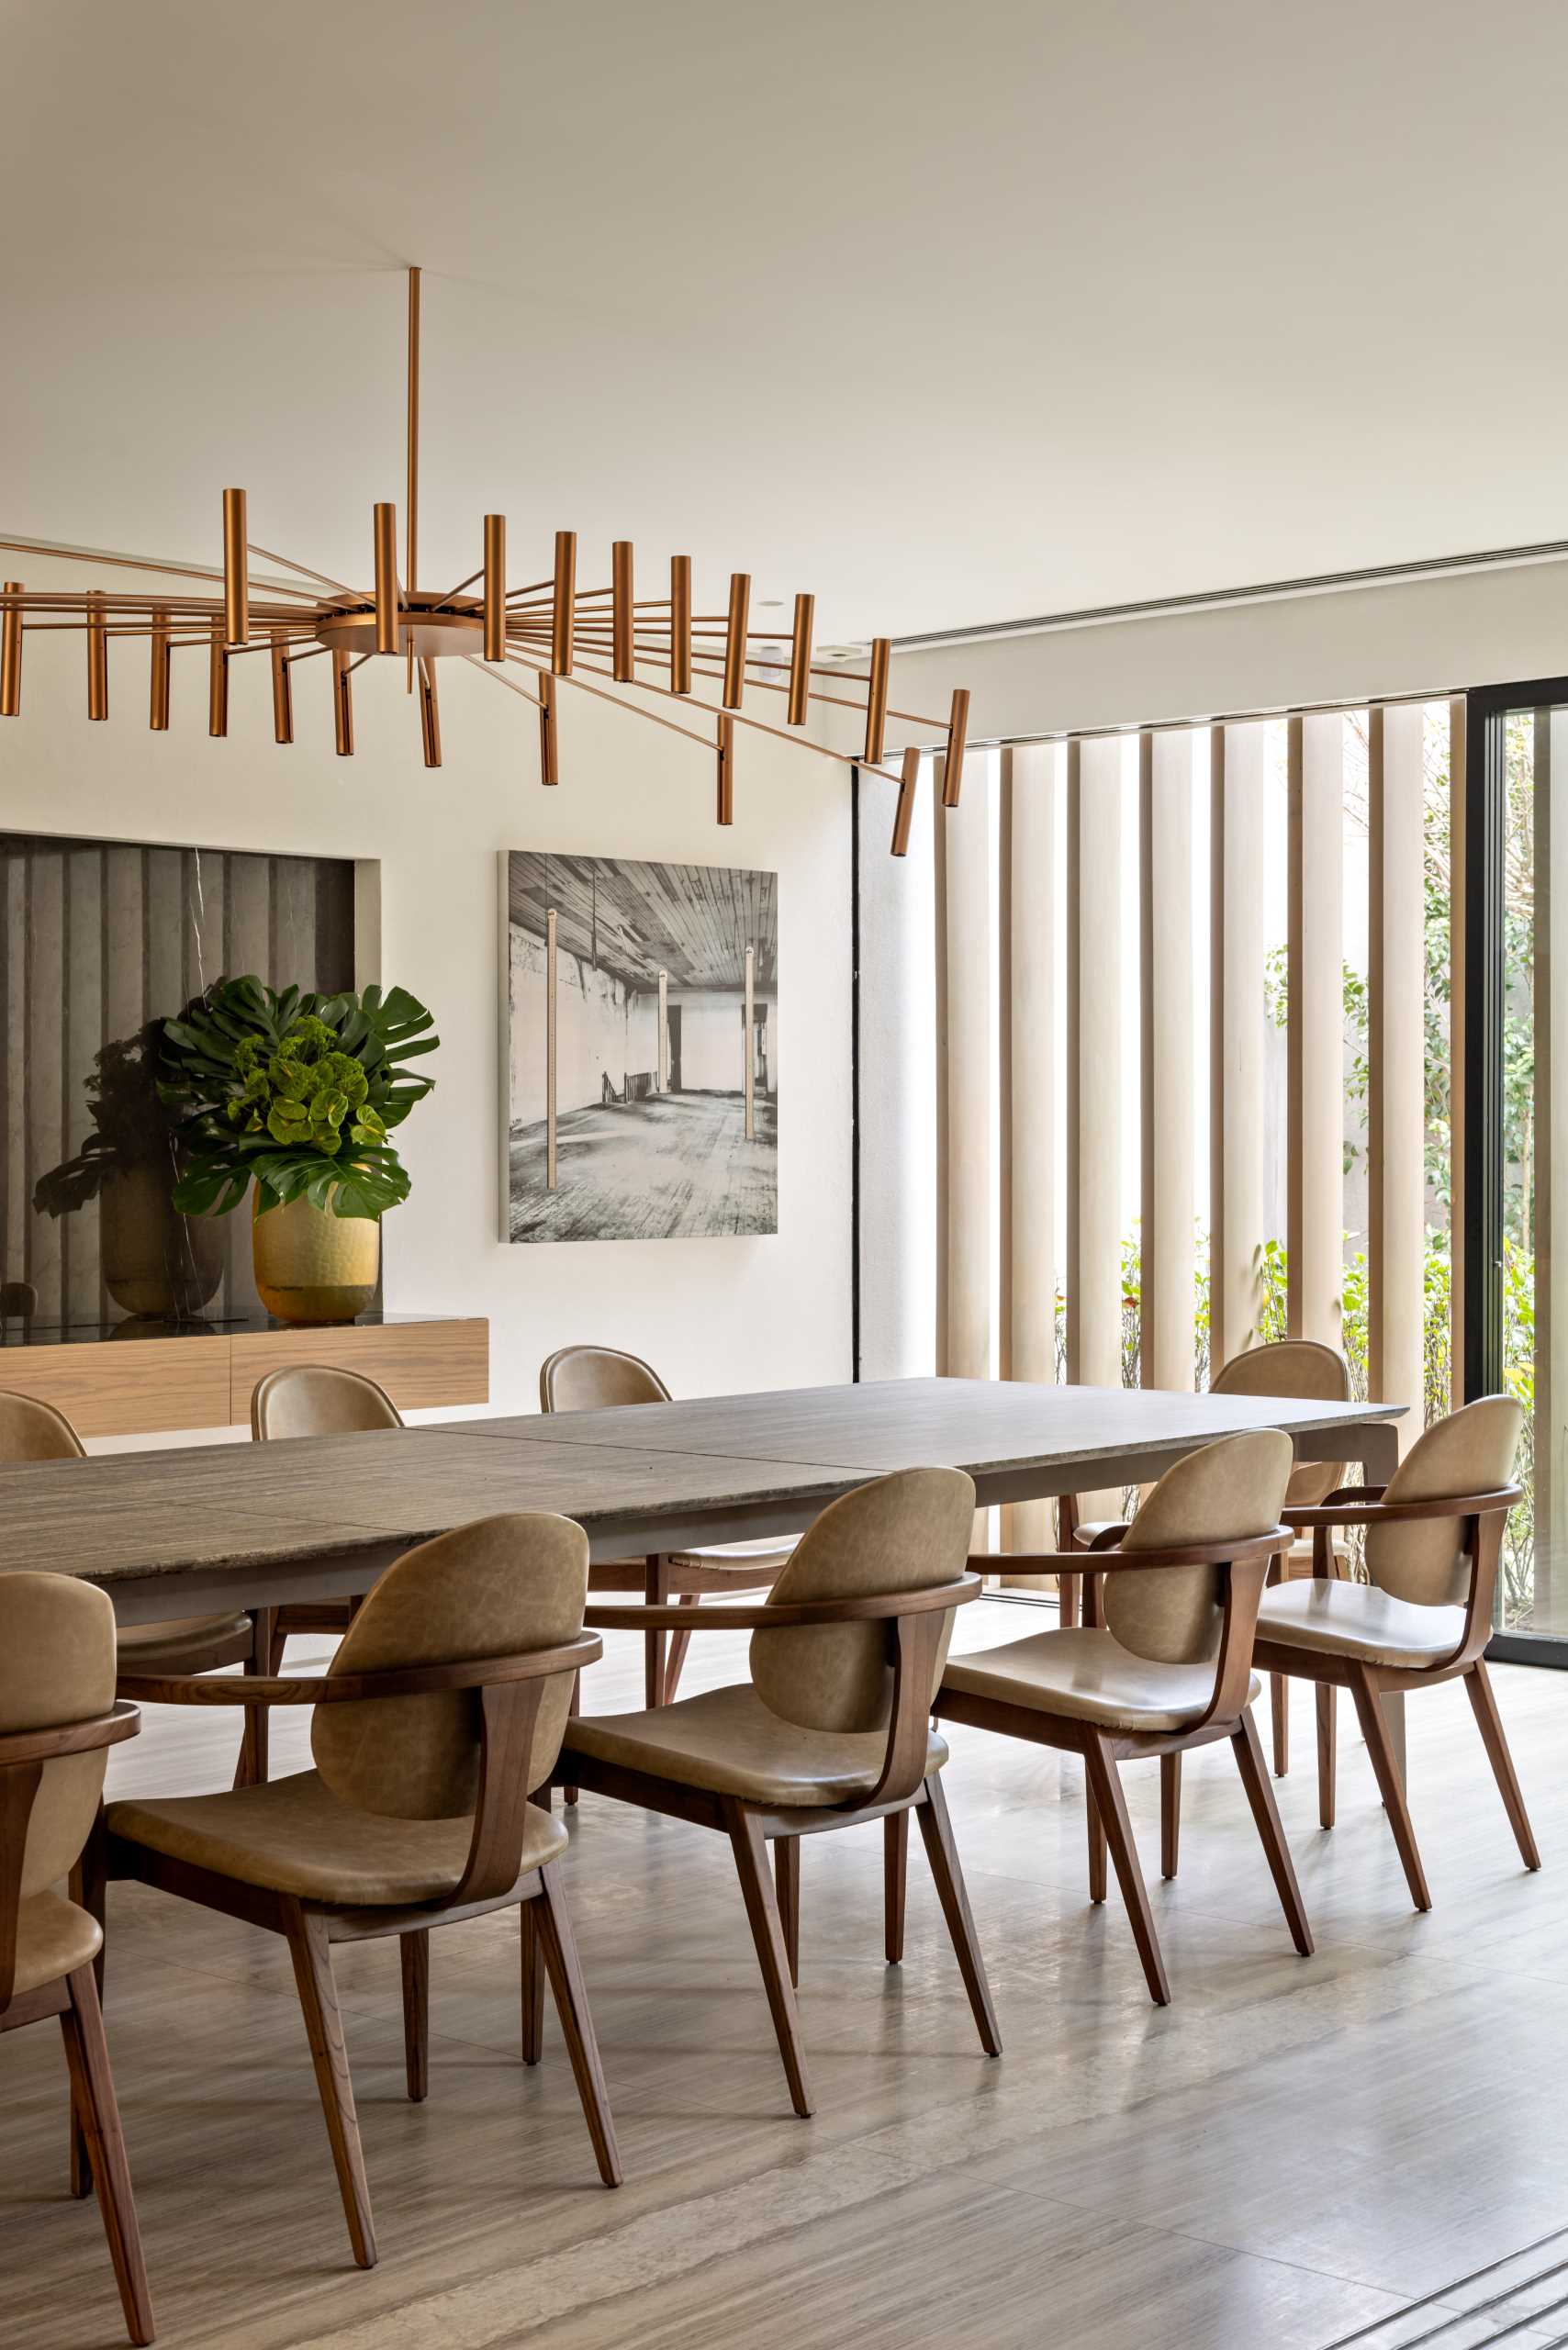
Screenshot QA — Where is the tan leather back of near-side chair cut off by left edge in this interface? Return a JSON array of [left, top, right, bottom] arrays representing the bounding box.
[[0, 1574, 115, 1898]]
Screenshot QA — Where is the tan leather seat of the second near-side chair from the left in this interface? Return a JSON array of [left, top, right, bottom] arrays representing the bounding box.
[[106, 1770, 566, 1906]]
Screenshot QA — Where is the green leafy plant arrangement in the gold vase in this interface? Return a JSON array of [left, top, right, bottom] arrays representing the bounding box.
[[158, 978, 440, 1217]]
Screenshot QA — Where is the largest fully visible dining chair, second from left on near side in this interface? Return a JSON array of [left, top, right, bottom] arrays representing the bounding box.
[[106, 1514, 621, 2267]]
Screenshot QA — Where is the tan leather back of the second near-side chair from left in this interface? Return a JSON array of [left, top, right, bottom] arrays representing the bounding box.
[[310, 1511, 588, 1818]]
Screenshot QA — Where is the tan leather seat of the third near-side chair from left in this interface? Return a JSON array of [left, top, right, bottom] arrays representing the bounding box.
[[566, 1682, 947, 1809]]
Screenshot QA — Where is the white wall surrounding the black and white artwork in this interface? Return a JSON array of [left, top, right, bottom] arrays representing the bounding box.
[[0, 597, 851, 1413]]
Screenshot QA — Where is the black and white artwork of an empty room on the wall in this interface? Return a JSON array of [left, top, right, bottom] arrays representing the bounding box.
[[500, 848, 778, 1241]]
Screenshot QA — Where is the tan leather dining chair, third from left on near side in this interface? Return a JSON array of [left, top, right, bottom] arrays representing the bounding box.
[[557, 1469, 1002, 2115]]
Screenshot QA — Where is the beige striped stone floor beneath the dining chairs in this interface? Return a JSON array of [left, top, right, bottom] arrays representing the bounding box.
[[0, 1600, 1568, 2350]]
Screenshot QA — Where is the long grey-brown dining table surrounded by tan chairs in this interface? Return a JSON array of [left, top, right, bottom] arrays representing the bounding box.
[[0, 1377, 1406, 1624]]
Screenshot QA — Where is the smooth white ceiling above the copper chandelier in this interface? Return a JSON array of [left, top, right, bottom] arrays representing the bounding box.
[[0, 0, 1568, 642]]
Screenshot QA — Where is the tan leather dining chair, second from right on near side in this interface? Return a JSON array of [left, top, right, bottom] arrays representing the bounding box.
[[935, 1428, 1312, 2007]]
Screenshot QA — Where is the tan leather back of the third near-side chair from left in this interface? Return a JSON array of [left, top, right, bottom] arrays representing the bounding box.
[[752, 1469, 976, 1729]]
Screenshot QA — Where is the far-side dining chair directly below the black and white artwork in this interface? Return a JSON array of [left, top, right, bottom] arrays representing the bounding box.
[[538, 1347, 797, 1710]]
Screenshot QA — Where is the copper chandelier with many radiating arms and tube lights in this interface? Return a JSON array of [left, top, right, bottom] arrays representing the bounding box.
[[0, 270, 969, 856]]
